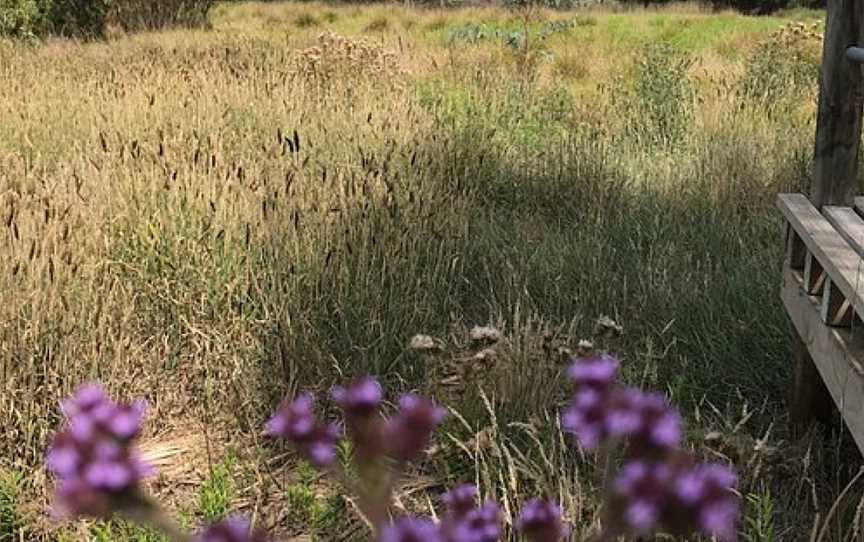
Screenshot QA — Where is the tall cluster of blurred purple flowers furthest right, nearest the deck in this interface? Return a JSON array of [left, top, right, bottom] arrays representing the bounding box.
[[561, 355, 739, 541]]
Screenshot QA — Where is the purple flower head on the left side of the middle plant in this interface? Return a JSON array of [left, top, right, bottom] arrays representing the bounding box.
[[265, 393, 341, 468]]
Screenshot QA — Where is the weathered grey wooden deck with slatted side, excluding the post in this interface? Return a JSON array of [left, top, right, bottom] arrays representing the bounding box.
[[777, 194, 864, 451]]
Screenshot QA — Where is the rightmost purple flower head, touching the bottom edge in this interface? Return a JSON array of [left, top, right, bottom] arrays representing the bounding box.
[[674, 463, 739, 541]]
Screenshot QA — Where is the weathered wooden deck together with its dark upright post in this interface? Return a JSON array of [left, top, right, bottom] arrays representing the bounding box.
[[779, 0, 864, 442]]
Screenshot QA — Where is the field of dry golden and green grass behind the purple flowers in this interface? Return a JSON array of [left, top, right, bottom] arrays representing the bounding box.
[[0, 3, 860, 540]]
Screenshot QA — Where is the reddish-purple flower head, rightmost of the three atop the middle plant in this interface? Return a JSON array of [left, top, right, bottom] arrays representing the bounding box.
[[384, 394, 447, 461]]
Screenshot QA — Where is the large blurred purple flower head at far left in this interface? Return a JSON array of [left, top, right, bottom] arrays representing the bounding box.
[[46, 384, 153, 517]]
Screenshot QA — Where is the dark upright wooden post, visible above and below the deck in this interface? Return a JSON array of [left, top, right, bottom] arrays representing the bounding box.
[[789, 0, 864, 434]]
